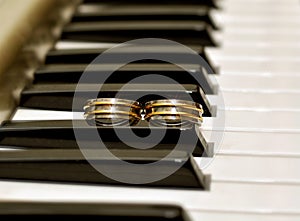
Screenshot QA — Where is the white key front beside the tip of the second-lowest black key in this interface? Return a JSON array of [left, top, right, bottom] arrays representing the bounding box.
[[200, 155, 300, 182]]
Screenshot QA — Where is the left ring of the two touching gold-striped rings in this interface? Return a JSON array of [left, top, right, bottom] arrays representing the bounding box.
[[83, 98, 142, 126]]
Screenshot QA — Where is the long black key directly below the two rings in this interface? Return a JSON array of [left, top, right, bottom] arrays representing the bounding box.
[[0, 120, 213, 157]]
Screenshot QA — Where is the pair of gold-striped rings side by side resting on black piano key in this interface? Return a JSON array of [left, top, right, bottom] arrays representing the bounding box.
[[84, 98, 203, 126]]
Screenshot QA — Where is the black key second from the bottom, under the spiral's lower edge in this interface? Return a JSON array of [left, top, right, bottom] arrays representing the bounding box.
[[0, 149, 209, 190]]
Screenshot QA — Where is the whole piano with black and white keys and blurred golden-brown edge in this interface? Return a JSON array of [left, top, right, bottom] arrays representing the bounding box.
[[0, 0, 300, 221]]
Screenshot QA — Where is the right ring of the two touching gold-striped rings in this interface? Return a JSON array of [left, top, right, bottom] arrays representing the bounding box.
[[145, 99, 203, 126]]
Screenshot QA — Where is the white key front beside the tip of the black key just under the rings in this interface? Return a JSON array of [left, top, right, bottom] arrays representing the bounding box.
[[201, 129, 300, 156]]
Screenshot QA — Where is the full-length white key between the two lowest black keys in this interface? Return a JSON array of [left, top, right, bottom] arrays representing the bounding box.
[[0, 181, 300, 216]]
